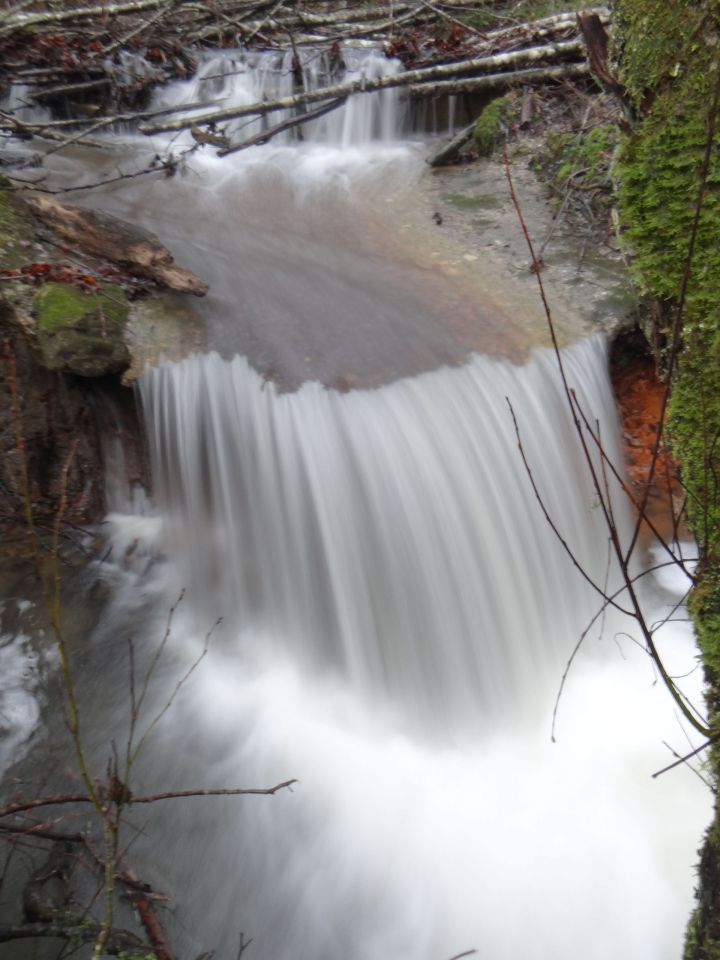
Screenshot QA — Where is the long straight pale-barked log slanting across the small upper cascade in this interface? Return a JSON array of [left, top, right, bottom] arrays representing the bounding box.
[[139, 40, 584, 136]]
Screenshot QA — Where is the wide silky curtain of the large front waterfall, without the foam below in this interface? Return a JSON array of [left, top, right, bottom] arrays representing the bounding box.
[[141, 338, 622, 731]]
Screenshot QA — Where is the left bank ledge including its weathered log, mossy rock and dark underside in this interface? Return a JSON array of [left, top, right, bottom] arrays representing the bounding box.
[[0, 178, 207, 549]]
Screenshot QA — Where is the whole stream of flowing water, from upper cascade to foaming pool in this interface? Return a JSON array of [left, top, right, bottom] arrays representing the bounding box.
[[0, 47, 709, 960]]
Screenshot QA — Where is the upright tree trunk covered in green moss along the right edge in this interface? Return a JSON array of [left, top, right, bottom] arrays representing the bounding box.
[[614, 0, 720, 960]]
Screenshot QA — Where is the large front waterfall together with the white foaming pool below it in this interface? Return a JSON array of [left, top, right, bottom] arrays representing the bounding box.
[[74, 340, 709, 960]]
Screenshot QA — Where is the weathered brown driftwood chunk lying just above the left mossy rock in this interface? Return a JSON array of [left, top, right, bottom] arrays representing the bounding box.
[[29, 197, 208, 297]]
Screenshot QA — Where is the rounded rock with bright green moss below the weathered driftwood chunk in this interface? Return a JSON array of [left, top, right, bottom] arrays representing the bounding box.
[[33, 283, 130, 377]]
